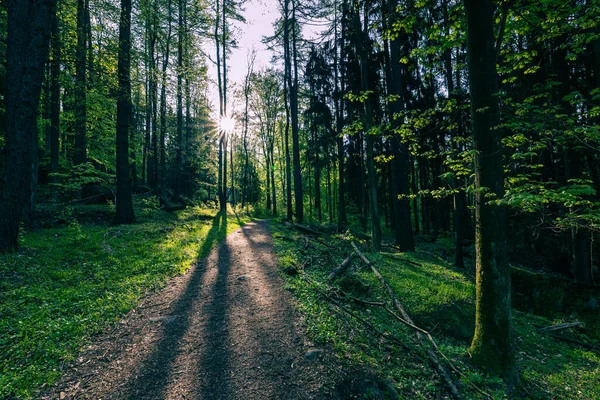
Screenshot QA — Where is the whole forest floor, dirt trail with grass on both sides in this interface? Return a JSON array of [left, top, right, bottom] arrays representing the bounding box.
[[0, 205, 600, 400]]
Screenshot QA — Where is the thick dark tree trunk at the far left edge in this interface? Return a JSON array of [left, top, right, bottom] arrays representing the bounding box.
[[0, 0, 56, 252]]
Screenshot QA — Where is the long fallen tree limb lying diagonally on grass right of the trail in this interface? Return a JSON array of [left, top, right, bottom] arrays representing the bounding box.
[[350, 242, 461, 399]]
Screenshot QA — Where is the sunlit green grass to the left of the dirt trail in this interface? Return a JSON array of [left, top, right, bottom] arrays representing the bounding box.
[[0, 206, 248, 398]]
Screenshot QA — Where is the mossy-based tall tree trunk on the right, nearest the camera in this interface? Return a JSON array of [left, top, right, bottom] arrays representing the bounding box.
[[464, 0, 517, 383]]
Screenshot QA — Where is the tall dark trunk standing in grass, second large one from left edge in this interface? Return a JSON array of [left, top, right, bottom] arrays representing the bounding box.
[[113, 0, 135, 225]]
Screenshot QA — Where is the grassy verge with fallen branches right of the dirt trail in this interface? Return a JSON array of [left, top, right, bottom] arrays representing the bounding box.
[[272, 222, 600, 399]]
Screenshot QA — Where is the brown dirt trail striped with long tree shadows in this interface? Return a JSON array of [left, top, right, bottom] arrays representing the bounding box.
[[42, 218, 350, 399]]
